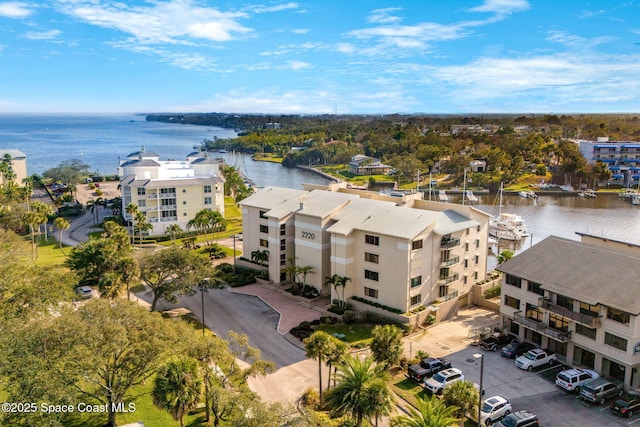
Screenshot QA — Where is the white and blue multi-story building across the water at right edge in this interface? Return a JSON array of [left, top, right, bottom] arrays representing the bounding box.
[[578, 137, 640, 186]]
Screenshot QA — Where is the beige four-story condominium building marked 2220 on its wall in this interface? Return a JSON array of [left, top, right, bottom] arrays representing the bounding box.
[[240, 184, 489, 312]]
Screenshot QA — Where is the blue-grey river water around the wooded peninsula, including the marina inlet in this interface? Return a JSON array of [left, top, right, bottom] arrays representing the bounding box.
[[0, 114, 640, 264]]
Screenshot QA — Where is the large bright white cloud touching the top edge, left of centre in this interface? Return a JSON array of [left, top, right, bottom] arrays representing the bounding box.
[[57, 0, 252, 44]]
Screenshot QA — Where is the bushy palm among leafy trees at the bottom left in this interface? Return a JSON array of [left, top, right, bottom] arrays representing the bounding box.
[[151, 356, 202, 427]]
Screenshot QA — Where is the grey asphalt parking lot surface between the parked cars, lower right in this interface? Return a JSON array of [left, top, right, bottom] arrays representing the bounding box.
[[446, 346, 640, 427]]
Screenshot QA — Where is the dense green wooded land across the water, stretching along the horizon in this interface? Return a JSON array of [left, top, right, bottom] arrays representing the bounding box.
[[148, 114, 640, 186]]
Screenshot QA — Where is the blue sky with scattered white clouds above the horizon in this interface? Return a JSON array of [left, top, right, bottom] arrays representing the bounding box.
[[0, 0, 640, 114]]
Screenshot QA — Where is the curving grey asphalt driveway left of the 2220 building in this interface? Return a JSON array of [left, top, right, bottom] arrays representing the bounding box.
[[138, 288, 305, 368]]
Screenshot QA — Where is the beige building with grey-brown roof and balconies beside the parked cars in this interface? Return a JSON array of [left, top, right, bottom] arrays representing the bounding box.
[[498, 233, 640, 389]]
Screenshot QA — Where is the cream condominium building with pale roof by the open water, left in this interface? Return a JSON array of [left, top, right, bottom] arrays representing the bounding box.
[[118, 147, 224, 235]]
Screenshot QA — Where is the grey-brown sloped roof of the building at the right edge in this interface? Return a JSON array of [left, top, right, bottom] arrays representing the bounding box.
[[497, 236, 640, 315]]
